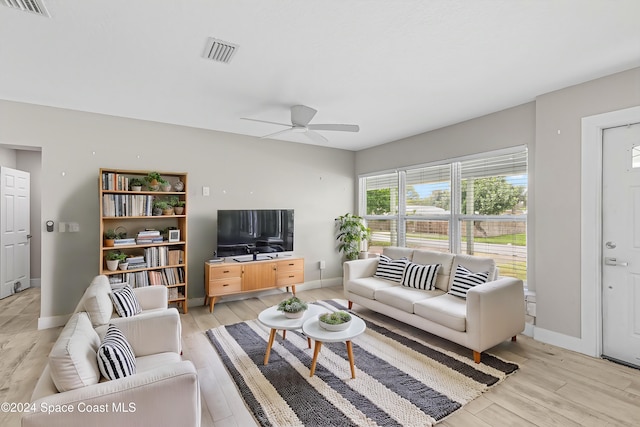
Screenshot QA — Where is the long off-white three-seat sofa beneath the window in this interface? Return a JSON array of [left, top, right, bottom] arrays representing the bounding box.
[[344, 247, 525, 363]]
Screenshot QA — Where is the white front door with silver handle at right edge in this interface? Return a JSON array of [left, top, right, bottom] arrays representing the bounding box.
[[602, 123, 640, 366]]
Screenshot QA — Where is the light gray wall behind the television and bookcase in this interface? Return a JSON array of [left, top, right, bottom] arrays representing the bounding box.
[[0, 101, 355, 320]]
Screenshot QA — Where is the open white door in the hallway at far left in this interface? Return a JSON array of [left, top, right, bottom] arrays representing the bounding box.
[[0, 167, 30, 298]]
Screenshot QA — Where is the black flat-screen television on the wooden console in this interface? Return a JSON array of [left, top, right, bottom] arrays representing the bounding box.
[[216, 209, 293, 258]]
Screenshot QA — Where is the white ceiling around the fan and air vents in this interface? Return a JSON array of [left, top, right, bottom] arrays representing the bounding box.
[[0, 0, 640, 150]]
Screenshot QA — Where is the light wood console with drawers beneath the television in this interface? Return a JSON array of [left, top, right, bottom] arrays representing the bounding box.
[[204, 257, 304, 312]]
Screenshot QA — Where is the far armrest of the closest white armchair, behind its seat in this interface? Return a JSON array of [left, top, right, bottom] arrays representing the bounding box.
[[105, 307, 182, 356]]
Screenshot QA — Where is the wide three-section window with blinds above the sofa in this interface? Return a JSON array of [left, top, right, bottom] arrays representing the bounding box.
[[360, 148, 528, 280]]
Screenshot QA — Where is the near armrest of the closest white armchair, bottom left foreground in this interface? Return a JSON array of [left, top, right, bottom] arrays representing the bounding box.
[[22, 361, 201, 427]]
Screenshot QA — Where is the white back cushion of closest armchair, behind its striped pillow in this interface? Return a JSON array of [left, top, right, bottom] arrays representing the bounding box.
[[49, 312, 100, 392]]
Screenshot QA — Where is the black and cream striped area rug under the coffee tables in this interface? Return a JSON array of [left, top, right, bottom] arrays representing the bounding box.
[[207, 300, 518, 426]]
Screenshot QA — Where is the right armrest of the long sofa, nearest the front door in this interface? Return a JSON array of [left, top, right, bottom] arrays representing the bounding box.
[[467, 277, 525, 352]]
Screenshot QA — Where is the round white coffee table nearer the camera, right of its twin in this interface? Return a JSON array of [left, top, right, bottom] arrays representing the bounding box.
[[302, 310, 367, 378]]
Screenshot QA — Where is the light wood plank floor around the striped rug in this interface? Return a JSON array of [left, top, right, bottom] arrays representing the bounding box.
[[0, 287, 640, 427]]
